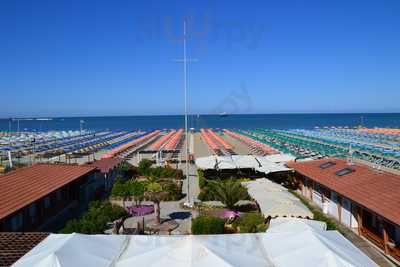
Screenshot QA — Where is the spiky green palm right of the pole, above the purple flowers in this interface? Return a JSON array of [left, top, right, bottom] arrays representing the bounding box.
[[211, 179, 249, 209]]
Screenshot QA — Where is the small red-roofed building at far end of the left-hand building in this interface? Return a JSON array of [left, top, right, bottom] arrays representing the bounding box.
[[89, 157, 123, 193]]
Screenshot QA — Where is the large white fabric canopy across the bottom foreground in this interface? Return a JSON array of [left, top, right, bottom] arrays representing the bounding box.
[[13, 230, 377, 267]]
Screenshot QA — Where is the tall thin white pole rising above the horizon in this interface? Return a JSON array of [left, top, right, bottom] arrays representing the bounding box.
[[183, 20, 191, 205]]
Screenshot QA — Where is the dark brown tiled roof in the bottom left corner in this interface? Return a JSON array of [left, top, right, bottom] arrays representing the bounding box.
[[0, 232, 49, 267]]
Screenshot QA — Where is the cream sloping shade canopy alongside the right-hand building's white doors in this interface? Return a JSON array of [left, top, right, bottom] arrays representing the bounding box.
[[242, 178, 313, 218]]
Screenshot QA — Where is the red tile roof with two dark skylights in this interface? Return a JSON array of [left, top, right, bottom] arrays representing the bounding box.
[[287, 158, 400, 225]]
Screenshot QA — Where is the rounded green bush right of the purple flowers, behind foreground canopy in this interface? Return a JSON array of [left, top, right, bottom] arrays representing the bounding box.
[[233, 213, 267, 233]]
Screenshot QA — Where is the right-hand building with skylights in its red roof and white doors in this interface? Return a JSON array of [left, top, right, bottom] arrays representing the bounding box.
[[287, 158, 400, 261]]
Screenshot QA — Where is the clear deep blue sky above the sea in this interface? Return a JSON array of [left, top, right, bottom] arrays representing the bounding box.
[[0, 0, 400, 117]]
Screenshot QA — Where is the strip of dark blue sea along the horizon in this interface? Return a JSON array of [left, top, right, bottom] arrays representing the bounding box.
[[0, 113, 400, 131]]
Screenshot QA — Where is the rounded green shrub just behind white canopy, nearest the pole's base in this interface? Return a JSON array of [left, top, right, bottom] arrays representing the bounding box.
[[192, 215, 225, 235]]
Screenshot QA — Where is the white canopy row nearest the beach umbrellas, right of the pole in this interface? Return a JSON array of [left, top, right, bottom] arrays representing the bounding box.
[[196, 155, 290, 174]]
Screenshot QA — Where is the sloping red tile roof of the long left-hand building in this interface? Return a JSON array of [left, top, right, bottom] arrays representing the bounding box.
[[0, 164, 95, 219]]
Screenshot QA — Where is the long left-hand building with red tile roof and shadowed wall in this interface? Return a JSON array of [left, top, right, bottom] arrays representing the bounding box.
[[0, 164, 96, 232]]
